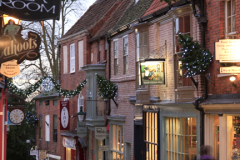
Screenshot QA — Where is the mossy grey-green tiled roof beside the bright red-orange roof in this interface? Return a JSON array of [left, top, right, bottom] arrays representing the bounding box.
[[109, 0, 153, 33]]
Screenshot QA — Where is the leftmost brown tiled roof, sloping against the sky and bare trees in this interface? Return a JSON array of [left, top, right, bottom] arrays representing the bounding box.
[[63, 0, 117, 38]]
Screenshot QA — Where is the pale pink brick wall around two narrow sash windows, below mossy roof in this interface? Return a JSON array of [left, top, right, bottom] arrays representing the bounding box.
[[111, 32, 136, 159]]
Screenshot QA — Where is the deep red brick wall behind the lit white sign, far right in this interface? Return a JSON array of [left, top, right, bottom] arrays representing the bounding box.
[[205, 0, 240, 94]]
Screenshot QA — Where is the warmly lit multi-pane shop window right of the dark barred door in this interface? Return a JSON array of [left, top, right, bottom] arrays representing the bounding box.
[[165, 117, 197, 160]]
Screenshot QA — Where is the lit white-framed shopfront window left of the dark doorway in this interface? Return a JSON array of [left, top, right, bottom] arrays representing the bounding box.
[[110, 124, 124, 160]]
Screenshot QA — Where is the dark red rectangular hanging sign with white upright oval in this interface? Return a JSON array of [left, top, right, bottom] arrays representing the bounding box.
[[60, 101, 70, 130]]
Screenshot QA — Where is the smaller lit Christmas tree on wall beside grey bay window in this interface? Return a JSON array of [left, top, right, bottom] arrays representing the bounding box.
[[96, 74, 118, 106]]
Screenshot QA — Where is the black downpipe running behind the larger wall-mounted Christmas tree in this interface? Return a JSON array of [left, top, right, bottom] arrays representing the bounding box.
[[192, 0, 208, 146]]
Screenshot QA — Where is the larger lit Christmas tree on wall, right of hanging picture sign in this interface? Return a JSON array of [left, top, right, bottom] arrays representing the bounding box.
[[178, 33, 213, 77]]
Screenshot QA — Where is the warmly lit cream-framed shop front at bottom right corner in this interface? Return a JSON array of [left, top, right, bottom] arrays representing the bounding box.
[[201, 96, 240, 160]]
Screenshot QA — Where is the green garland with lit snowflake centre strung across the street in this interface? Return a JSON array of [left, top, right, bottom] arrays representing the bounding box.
[[7, 76, 87, 97]]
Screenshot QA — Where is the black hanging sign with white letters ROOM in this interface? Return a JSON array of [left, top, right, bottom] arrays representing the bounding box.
[[0, 0, 61, 21]]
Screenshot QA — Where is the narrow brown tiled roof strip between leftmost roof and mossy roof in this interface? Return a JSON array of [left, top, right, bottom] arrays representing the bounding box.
[[92, 0, 134, 40]]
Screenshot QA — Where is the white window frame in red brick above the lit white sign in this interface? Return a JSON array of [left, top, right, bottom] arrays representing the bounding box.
[[225, 0, 236, 38]]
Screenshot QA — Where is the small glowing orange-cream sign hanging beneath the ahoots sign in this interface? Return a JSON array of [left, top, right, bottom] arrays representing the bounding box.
[[0, 60, 20, 78]]
